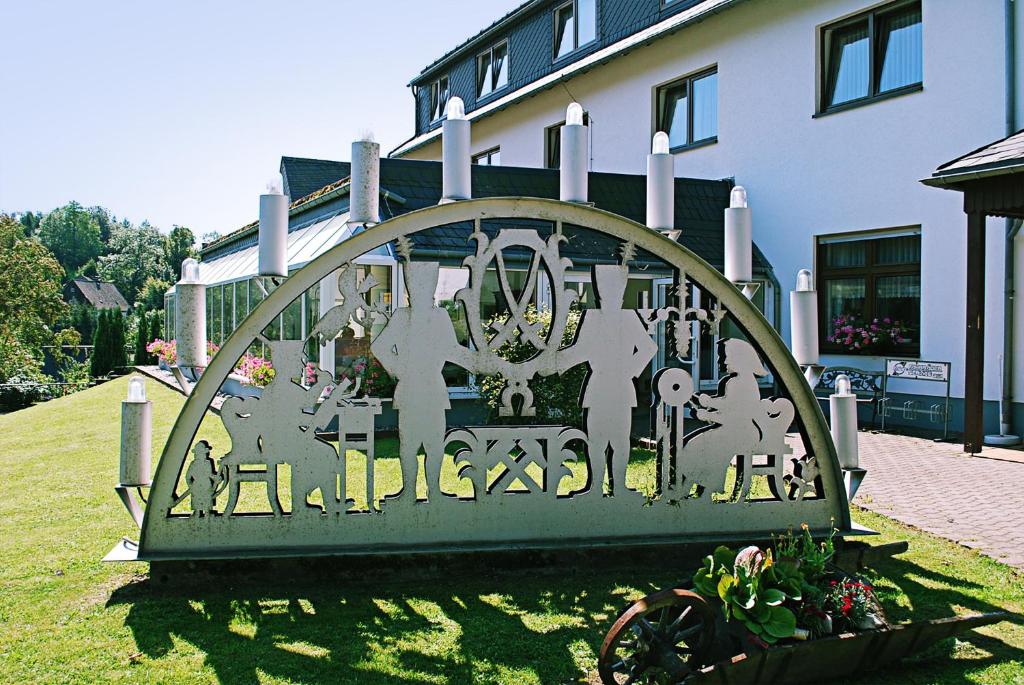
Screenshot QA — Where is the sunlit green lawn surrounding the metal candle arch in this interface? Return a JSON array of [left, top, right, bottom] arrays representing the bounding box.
[[0, 379, 1024, 685]]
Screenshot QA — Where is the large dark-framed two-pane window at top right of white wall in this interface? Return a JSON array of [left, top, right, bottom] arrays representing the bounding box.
[[819, 0, 924, 112]]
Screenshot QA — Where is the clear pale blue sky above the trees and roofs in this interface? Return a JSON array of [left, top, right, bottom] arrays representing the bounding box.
[[0, 0, 520, 236]]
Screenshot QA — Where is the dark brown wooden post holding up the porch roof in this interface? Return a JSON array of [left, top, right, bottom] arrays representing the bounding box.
[[964, 211, 985, 455]]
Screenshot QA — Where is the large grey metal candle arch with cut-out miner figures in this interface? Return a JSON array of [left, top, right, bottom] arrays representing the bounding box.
[[137, 198, 851, 560]]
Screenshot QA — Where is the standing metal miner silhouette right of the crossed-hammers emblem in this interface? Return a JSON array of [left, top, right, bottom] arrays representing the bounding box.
[[557, 264, 657, 495]]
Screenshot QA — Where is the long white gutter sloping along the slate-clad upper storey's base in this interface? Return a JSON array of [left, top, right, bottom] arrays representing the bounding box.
[[388, 0, 739, 157]]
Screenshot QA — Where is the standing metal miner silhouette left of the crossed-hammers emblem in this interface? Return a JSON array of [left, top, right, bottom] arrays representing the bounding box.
[[370, 262, 473, 506]]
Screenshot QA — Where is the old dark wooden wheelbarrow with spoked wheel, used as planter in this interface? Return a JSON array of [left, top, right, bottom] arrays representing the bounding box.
[[598, 543, 1008, 685]]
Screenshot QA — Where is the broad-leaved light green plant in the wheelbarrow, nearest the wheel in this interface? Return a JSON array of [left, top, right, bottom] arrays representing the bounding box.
[[693, 547, 803, 644]]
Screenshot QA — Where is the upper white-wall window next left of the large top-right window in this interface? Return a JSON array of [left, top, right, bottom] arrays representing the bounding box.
[[655, 68, 718, 151]]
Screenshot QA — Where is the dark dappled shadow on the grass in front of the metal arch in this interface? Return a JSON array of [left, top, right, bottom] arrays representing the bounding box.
[[110, 548, 1024, 684]]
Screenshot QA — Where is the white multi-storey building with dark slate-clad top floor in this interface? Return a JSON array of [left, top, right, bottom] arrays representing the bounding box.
[[392, 0, 1024, 432]]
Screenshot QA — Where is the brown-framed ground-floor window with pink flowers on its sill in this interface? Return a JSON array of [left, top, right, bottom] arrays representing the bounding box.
[[817, 229, 921, 355]]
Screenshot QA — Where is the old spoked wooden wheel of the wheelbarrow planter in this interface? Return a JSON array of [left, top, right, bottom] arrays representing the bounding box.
[[597, 590, 717, 685]]
